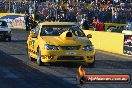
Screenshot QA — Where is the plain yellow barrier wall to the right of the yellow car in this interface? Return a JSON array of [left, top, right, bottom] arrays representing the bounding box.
[[84, 30, 124, 54]]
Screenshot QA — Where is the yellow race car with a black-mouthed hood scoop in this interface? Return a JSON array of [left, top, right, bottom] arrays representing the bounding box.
[[27, 22, 95, 66]]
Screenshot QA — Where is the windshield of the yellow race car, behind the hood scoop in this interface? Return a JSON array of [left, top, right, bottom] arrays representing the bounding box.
[[40, 25, 85, 37]]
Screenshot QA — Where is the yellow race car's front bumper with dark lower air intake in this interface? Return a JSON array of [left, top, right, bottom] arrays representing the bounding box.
[[41, 50, 95, 63]]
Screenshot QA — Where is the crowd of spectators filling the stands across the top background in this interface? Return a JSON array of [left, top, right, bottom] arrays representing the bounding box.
[[0, 0, 132, 23]]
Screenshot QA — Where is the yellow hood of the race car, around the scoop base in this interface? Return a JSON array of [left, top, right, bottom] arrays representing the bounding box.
[[41, 36, 91, 46]]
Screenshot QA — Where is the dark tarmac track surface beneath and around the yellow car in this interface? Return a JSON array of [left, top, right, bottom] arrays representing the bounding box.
[[0, 30, 132, 88]]
